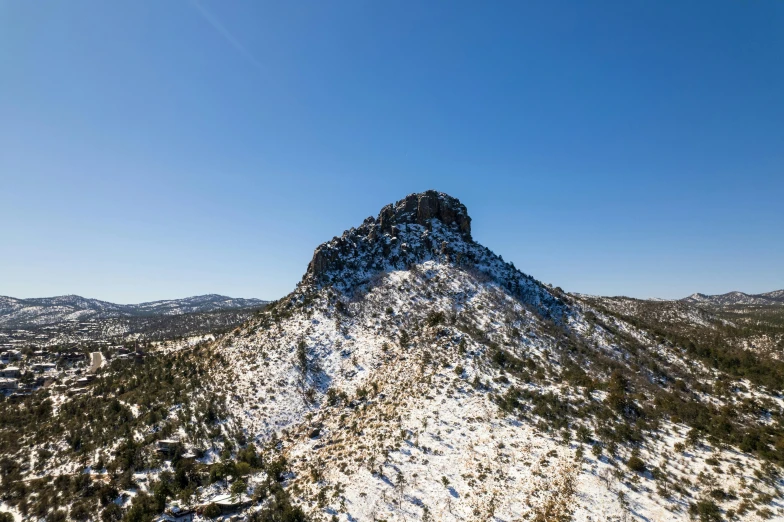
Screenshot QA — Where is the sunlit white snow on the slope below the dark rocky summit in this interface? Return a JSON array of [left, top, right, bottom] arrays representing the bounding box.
[[213, 261, 784, 521]]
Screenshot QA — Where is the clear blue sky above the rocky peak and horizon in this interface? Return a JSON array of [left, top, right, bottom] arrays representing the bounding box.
[[0, 0, 784, 302]]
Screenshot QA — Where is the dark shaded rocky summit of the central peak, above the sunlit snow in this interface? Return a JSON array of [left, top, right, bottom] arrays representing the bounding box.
[[300, 190, 565, 316]]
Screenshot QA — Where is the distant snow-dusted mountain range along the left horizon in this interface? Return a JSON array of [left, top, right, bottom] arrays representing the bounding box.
[[0, 294, 267, 328]]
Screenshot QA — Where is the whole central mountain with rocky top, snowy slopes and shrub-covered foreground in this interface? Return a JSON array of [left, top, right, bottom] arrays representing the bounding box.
[[0, 191, 784, 522]]
